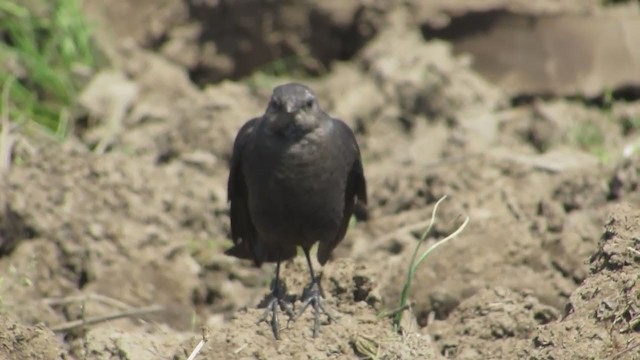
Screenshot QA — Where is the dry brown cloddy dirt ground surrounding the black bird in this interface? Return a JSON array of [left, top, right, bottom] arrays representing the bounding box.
[[0, 0, 640, 360]]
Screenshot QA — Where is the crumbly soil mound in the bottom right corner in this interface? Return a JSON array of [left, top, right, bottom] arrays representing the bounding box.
[[424, 204, 640, 359]]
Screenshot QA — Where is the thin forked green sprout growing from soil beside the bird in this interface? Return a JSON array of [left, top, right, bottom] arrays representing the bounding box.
[[393, 195, 469, 330]]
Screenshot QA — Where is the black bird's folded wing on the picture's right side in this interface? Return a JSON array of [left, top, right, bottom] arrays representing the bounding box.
[[318, 120, 367, 265]]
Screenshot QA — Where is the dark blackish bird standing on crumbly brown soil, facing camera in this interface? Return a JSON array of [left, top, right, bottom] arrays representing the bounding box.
[[225, 83, 367, 338]]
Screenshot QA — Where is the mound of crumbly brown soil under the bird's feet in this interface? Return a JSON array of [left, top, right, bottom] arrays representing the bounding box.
[[177, 258, 440, 359]]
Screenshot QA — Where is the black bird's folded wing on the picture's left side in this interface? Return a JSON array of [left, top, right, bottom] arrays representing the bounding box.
[[225, 118, 260, 261]]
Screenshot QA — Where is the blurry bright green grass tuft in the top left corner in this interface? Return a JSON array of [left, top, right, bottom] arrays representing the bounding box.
[[0, 0, 96, 140]]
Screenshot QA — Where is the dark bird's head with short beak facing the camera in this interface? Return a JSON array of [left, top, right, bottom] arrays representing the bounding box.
[[265, 83, 324, 133]]
